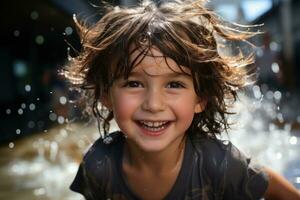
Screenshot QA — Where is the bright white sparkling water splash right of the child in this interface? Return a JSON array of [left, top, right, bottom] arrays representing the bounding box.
[[223, 92, 300, 189]]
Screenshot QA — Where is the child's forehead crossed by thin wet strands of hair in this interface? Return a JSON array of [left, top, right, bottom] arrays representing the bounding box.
[[130, 46, 191, 76]]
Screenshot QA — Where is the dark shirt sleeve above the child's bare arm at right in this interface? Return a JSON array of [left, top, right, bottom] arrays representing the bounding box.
[[221, 143, 268, 200]]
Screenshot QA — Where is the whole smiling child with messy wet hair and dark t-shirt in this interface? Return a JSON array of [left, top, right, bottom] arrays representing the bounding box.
[[65, 0, 300, 200]]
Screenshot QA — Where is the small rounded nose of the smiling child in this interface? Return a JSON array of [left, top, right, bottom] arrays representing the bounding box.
[[142, 89, 165, 113]]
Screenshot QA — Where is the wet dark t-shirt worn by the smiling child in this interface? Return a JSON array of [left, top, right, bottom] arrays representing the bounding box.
[[70, 132, 268, 200]]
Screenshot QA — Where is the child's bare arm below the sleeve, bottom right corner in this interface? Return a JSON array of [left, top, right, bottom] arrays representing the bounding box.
[[263, 168, 300, 200]]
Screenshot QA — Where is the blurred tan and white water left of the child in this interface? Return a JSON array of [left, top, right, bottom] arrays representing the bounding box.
[[0, 124, 98, 200]]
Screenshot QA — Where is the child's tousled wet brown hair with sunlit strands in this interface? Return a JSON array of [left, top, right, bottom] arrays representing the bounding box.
[[63, 0, 256, 137]]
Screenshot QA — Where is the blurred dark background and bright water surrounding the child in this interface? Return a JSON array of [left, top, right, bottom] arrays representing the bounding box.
[[0, 0, 300, 200]]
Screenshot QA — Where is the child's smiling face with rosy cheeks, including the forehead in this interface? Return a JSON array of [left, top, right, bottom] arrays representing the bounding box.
[[103, 48, 205, 152]]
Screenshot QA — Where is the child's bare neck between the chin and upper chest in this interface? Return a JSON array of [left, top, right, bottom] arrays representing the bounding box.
[[123, 137, 186, 174]]
